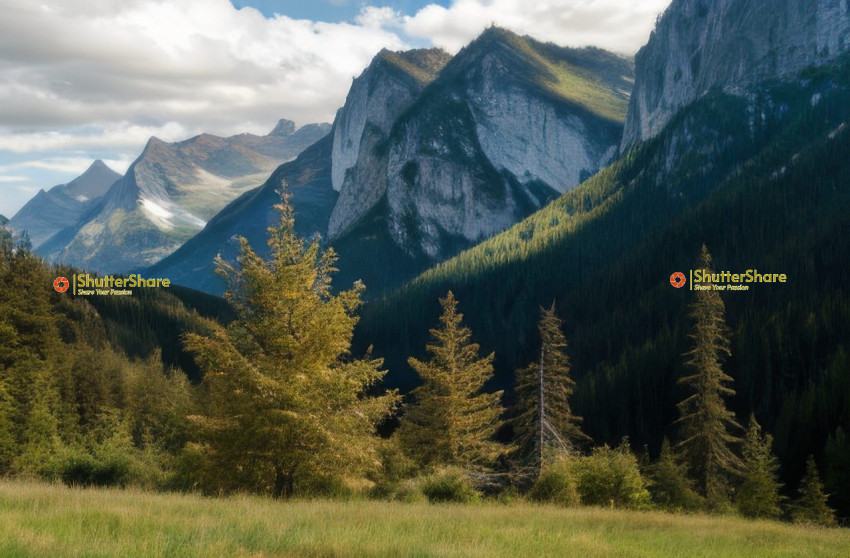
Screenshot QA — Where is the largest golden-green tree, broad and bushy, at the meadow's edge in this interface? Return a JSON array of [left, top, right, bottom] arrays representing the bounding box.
[[185, 194, 397, 497]]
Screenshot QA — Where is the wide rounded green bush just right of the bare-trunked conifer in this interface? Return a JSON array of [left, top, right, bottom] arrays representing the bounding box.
[[570, 442, 651, 509]]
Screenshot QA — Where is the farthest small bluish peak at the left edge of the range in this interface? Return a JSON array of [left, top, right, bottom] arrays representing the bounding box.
[[9, 159, 121, 248]]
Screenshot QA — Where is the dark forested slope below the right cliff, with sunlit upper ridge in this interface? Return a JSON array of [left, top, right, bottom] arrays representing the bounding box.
[[353, 1, 850, 516]]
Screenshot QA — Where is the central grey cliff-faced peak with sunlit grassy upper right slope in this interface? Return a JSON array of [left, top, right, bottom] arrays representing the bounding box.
[[328, 28, 632, 263]]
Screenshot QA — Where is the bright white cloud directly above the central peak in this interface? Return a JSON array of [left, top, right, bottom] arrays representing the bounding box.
[[404, 0, 670, 54]]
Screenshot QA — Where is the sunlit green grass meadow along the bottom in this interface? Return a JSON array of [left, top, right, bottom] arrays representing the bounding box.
[[0, 481, 850, 558]]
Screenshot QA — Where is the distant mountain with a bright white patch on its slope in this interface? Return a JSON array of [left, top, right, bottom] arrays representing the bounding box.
[[38, 120, 329, 273]]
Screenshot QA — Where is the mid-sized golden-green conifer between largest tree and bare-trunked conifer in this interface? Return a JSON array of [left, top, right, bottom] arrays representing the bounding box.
[[399, 291, 504, 468]]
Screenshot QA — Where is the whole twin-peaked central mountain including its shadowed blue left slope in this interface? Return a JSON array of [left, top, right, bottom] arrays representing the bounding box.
[[150, 28, 633, 296]]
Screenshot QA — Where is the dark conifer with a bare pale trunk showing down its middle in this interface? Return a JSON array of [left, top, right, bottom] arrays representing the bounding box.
[[511, 302, 590, 471]]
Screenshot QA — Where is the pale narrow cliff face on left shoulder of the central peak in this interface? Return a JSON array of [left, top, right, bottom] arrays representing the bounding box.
[[328, 49, 451, 238]]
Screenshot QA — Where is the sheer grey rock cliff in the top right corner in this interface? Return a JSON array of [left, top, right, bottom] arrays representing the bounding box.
[[621, 0, 850, 152]]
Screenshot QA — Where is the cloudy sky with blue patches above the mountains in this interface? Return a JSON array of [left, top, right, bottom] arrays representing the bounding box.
[[0, 0, 670, 217]]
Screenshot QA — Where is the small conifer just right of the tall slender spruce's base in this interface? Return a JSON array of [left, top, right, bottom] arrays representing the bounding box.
[[735, 415, 782, 519]]
